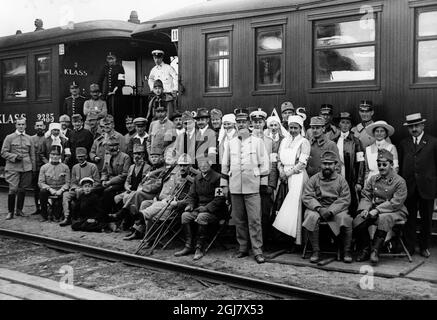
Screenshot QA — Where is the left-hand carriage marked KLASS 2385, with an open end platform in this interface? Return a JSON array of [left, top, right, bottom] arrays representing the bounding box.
[[0, 20, 176, 172]]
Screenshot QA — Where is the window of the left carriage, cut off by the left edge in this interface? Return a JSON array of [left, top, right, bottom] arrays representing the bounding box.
[[1, 57, 27, 101]]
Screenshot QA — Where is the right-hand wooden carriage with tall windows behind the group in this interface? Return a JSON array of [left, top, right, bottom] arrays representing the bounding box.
[[132, 0, 437, 142]]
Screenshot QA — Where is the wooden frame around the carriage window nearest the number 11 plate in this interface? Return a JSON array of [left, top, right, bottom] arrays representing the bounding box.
[[201, 25, 233, 97]]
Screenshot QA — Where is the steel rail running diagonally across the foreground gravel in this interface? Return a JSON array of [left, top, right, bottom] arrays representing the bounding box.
[[0, 228, 353, 300]]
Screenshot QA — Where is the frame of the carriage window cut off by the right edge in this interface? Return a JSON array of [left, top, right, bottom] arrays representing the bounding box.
[[410, 5, 437, 88]]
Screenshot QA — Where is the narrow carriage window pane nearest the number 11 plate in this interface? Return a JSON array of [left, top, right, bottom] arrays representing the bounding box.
[[206, 33, 230, 92]]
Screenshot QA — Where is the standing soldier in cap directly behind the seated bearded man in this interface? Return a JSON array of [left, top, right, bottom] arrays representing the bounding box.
[[307, 117, 338, 177]]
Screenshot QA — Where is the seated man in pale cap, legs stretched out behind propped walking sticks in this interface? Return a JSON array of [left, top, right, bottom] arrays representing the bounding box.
[[125, 155, 191, 241]]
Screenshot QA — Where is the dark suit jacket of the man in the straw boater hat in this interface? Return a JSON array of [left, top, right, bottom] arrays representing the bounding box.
[[399, 133, 437, 199]]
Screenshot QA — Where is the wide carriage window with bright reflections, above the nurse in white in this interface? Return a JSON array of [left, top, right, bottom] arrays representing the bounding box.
[[313, 17, 376, 84]]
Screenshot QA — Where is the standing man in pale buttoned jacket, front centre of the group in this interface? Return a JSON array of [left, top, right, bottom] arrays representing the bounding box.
[[221, 109, 269, 263]]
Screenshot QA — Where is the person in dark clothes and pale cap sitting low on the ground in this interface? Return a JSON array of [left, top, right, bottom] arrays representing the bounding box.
[[71, 178, 106, 232]]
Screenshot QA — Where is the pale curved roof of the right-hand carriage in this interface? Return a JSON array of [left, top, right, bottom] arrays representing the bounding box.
[[132, 0, 362, 37]]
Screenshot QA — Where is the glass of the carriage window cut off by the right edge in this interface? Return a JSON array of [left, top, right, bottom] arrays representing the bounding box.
[[416, 9, 437, 82]]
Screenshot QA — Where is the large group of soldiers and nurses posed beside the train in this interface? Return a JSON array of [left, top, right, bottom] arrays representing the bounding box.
[[1, 70, 437, 263]]
